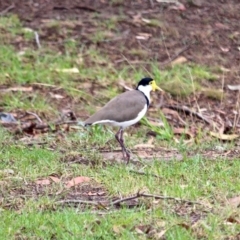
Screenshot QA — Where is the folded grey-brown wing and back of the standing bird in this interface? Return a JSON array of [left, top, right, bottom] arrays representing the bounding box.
[[85, 90, 147, 124]]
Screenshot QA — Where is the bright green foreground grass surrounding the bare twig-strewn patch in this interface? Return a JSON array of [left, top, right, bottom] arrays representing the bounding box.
[[0, 136, 240, 239]]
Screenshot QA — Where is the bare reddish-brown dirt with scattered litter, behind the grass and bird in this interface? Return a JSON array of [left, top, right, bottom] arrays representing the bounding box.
[[0, 0, 240, 137]]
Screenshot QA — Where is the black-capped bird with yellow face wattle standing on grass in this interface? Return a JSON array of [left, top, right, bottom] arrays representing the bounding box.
[[84, 77, 163, 163]]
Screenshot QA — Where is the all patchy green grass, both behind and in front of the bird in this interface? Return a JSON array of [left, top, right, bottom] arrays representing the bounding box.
[[0, 14, 240, 240]]
